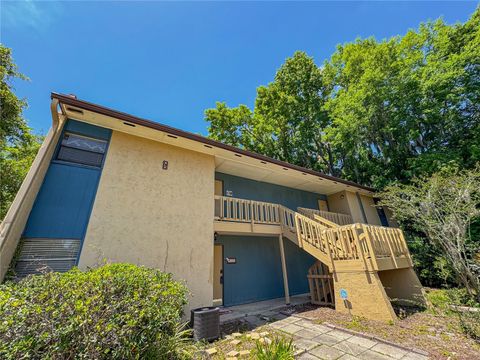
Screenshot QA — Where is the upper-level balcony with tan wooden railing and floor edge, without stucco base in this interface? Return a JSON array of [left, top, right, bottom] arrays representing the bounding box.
[[214, 196, 412, 271]]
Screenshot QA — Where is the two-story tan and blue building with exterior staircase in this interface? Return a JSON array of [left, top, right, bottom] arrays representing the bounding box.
[[0, 93, 423, 319]]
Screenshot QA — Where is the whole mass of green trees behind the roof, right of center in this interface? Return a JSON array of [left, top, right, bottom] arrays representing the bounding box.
[[205, 9, 480, 189]]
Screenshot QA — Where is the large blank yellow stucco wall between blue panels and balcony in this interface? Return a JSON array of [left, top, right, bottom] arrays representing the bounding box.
[[79, 131, 215, 308]]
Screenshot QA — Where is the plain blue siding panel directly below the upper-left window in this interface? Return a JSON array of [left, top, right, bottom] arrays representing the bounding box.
[[23, 163, 100, 239]]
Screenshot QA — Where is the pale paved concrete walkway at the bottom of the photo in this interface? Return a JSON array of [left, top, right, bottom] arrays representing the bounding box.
[[268, 315, 428, 360]]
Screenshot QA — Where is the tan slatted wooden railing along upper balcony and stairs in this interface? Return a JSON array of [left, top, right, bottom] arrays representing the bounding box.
[[215, 196, 411, 270]]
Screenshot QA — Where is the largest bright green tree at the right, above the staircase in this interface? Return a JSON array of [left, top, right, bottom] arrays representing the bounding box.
[[323, 10, 480, 188]]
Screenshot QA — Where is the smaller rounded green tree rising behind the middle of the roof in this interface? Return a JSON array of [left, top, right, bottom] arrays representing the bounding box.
[[205, 51, 338, 174]]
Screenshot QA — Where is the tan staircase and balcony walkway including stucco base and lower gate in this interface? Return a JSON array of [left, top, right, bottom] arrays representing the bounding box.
[[214, 196, 425, 320]]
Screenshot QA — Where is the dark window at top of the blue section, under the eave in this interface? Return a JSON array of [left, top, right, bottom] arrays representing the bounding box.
[[57, 133, 107, 167]]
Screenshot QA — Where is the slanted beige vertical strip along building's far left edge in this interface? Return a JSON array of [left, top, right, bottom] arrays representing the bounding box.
[[0, 99, 63, 281]]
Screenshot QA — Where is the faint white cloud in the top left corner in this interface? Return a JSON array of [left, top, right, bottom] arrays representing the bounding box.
[[0, 0, 62, 31]]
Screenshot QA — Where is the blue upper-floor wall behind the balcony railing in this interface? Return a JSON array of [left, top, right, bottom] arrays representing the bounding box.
[[215, 172, 327, 210]]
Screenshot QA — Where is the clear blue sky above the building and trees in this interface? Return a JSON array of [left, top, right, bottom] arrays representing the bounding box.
[[1, 1, 478, 134]]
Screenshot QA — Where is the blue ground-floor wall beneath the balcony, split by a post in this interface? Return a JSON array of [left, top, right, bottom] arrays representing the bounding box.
[[216, 235, 315, 306]]
